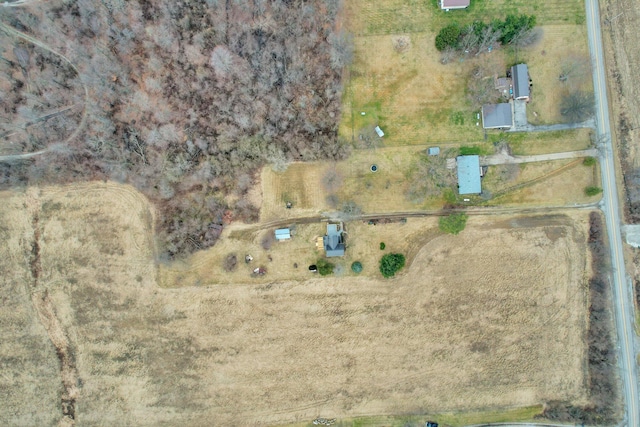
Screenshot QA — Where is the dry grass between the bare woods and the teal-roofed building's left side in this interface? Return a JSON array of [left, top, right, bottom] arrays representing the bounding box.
[[260, 149, 457, 222]]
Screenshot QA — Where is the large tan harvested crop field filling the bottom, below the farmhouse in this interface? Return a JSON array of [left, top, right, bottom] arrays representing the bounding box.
[[0, 183, 589, 425]]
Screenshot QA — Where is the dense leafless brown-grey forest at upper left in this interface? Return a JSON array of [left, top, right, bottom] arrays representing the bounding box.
[[0, 0, 352, 257]]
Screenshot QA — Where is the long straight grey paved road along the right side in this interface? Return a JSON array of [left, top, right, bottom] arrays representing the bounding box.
[[585, 0, 640, 427]]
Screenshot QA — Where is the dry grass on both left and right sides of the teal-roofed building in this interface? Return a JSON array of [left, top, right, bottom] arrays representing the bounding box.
[[260, 147, 599, 222]]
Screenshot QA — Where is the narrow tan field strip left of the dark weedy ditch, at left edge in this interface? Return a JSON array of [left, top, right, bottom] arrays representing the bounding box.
[[0, 193, 61, 426]]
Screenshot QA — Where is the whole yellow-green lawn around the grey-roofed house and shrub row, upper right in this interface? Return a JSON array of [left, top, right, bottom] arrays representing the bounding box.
[[340, 0, 590, 146]]
